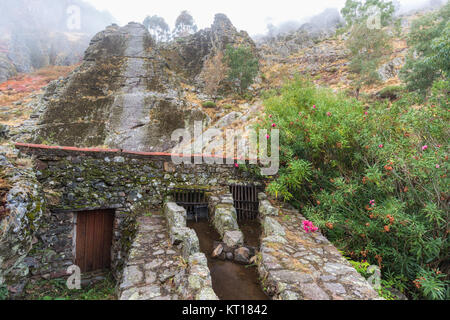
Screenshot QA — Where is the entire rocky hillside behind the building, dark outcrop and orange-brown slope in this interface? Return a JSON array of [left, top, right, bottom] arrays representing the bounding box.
[[0, 10, 432, 155]]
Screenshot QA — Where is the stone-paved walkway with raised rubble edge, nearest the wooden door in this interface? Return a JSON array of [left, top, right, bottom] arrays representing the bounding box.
[[119, 208, 218, 300]]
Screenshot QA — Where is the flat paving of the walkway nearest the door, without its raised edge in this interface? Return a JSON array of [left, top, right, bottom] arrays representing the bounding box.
[[119, 215, 184, 300]]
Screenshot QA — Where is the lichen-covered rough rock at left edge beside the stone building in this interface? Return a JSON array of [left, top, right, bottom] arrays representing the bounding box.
[[0, 147, 46, 296]]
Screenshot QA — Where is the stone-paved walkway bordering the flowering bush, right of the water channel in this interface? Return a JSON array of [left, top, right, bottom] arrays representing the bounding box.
[[258, 196, 381, 300]]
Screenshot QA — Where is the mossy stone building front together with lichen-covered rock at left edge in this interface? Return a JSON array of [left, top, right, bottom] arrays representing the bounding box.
[[0, 144, 258, 298]]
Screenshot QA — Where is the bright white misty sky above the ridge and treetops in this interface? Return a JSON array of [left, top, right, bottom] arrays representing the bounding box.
[[85, 0, 432, 35]]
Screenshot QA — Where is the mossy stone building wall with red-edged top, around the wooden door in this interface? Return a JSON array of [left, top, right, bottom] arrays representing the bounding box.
[[16, 144, 260, 288]]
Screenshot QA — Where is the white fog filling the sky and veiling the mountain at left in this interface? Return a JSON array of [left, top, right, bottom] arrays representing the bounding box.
[[0, 0, 440, 81]]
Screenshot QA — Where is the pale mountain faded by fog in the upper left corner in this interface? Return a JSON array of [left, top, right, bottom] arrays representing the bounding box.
[[0, 0, 115, 82]]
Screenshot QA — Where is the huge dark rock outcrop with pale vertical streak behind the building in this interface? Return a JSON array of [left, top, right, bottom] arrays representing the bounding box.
[[29, 15, 255, 151]]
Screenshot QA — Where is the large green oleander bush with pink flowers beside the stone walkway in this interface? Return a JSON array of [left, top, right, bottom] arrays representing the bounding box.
[[263, 80, 449, 299]]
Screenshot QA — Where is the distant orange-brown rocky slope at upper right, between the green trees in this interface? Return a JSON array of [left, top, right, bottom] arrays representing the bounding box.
[[258, 10, 425, 94]]
